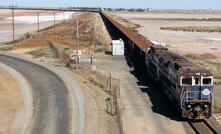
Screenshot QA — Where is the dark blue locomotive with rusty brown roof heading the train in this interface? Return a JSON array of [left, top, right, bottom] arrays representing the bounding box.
[[145, 45, 213, 120]]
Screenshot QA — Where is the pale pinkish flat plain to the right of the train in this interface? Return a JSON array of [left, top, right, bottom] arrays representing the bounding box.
[[113, 12, 221, 59]]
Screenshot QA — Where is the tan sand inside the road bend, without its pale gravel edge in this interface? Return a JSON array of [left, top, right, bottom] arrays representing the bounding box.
[[0, 68, 23, 134]]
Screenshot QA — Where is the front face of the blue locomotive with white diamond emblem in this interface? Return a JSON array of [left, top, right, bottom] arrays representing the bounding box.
[[180, 75, 213, 119]]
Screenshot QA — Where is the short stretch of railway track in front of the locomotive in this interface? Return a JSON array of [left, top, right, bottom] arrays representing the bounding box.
[[188, 120, 218, 134]]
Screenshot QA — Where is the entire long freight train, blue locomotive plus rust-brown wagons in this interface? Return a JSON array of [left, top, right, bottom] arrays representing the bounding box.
[[100, 12, 213, 120]]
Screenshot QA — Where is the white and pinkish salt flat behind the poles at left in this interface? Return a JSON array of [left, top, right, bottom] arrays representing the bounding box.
[[0, 11, 74, 43]]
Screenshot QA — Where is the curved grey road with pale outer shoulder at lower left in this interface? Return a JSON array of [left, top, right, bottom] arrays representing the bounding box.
[[0, 54, 84, 134]]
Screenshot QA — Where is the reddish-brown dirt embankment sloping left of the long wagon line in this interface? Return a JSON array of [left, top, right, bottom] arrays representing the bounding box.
[[2, 13, 111, 52]]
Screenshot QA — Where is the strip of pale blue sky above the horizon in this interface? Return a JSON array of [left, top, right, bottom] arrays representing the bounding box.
[[0, 0, 221, 10]]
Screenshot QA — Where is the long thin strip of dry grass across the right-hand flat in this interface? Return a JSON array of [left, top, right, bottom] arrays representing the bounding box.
[[160, 26, 221, 33]]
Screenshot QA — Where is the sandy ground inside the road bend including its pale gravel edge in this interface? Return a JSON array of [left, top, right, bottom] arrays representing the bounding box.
[[0, 63, 33, 134]]
